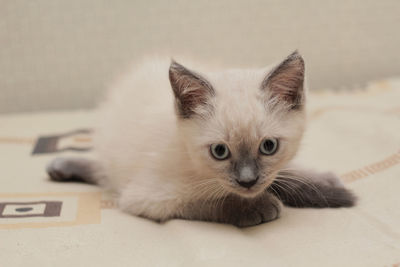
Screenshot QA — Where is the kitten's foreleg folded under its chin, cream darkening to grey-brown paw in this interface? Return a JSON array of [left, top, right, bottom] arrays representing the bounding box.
[[119, 175, 282, 227]]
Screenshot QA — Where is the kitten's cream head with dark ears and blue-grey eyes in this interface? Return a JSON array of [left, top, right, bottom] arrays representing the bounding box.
[[169, 51, 305, 197]]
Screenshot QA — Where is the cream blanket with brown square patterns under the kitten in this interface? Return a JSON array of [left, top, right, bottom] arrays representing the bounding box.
[[0, 79, 400, 267]]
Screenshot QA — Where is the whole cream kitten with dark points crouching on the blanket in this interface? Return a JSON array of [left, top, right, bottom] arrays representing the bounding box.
[[47, 51, 355, 227]]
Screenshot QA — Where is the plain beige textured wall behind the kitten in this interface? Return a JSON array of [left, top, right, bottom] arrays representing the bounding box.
[[0, 0, 400, 112]]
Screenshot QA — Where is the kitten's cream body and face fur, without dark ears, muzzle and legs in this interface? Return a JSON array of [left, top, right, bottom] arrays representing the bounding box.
[[95, 57, 304, 220]]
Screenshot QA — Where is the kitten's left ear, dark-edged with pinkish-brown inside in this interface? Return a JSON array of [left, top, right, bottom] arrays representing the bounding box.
[[169, 61, 215, 118]]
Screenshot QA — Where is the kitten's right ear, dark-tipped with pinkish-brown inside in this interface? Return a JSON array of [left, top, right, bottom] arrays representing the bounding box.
[[261, 50, 304, 109]]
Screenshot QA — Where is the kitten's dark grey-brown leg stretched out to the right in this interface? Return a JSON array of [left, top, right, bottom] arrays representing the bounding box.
[[270, 168, 356, 208]]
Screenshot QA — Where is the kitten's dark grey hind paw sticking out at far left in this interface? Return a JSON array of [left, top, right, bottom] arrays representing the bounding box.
[[46, 157, 99, 184]]
